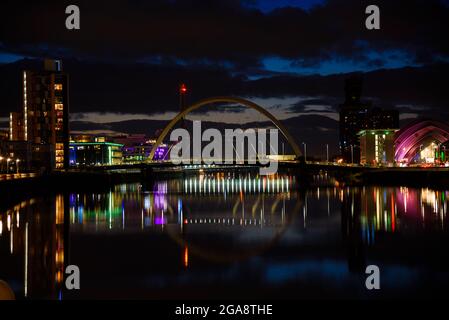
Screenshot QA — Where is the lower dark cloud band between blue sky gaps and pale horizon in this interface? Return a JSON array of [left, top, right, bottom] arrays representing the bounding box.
[[0, 60, 449, 119]]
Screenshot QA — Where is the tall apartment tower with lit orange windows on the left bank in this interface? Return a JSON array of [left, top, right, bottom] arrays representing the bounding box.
[[9, 60, 69, 169]]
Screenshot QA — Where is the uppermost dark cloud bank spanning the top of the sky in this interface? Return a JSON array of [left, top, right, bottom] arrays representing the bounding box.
[[0, 0, 449, 69]]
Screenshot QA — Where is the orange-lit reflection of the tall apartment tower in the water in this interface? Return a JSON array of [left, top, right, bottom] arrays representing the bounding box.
[[0, 195, 68, 299]]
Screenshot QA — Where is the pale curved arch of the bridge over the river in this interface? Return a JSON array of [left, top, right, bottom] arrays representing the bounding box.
[[148, 97, 301, 161]]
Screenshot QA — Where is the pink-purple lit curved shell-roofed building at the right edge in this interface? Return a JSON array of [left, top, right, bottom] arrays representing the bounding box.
[[395, 120, 449, 163]]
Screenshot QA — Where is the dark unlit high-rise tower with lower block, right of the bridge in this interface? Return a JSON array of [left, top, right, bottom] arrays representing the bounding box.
[[340, 77, 399, 163]]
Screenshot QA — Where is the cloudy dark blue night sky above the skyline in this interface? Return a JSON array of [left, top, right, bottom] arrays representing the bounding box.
[[0, 0, 449, 152]]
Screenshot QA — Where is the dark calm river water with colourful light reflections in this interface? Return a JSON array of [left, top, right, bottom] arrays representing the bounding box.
[[0, 174, 449, 299]]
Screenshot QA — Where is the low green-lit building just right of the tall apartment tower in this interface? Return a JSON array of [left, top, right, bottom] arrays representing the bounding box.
[[70, 136, 123, 166]]
